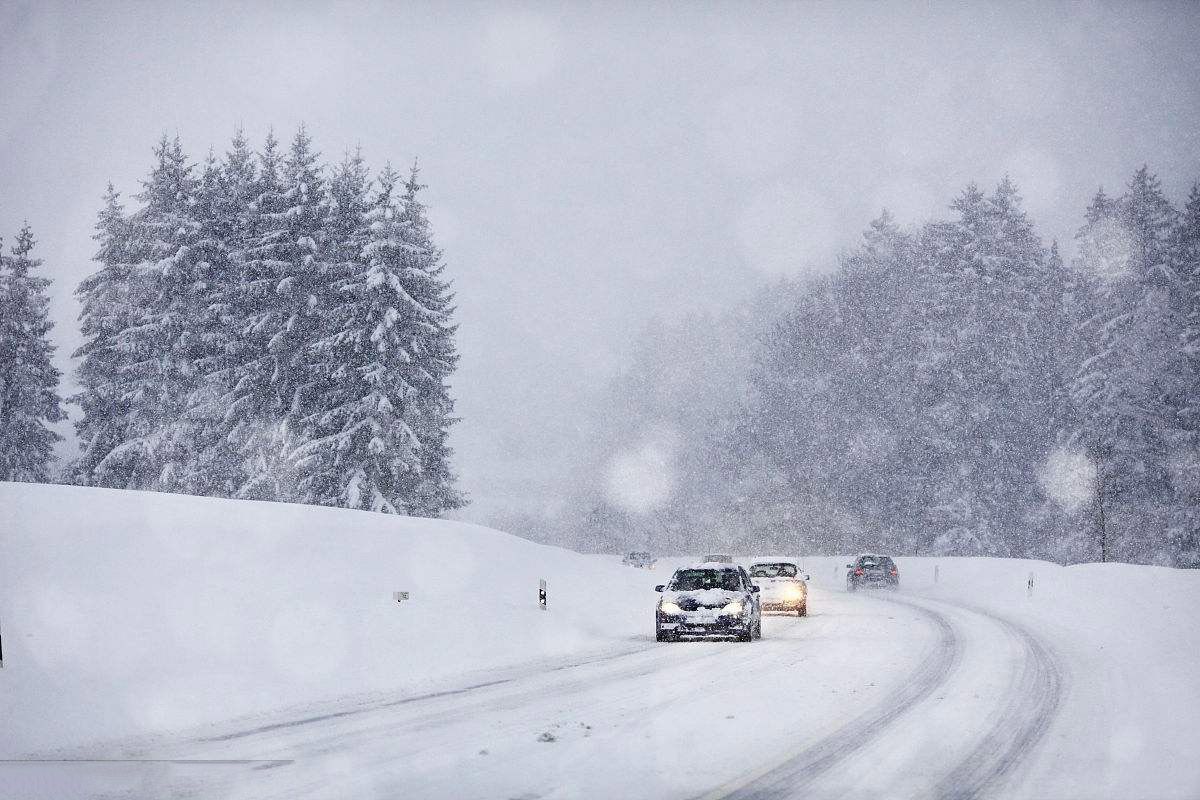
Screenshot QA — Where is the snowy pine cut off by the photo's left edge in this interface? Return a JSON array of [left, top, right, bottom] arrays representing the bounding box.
[[0, 224, 66, 482]]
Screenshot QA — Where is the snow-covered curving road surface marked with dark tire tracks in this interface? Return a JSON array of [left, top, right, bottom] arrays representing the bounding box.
[[14, 591, 1066, 799]]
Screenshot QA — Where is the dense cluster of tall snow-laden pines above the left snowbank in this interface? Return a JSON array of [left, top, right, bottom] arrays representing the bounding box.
[[0, 128, 464, 516]]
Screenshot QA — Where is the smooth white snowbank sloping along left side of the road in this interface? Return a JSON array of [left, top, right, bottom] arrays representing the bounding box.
[[0, 482, 656, 756]]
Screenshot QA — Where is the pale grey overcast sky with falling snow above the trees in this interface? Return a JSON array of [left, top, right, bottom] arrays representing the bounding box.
[[0, 0, 1200, 518]]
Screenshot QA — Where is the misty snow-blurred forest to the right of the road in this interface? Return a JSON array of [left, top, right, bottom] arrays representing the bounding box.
[[564, 169, 1200, 566]]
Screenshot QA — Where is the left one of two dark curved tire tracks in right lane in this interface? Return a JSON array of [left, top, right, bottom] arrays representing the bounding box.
[[701, 601, 962, 800]]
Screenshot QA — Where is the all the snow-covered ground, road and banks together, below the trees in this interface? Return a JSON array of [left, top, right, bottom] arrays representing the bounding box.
[[0, 483, 1200, 799]]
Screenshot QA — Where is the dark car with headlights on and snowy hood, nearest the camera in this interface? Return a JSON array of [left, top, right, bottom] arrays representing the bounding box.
[[654, 561, 762, 642]]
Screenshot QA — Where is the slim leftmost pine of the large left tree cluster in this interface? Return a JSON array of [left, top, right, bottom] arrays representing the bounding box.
[[66, 184, 142, 487]]
